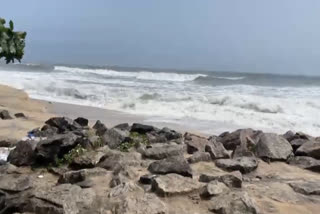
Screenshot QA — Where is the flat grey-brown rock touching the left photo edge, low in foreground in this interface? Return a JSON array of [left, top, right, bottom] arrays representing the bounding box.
[[0, 174, 32, 192]]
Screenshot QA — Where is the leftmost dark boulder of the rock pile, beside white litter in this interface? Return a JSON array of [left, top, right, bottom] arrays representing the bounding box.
[[7, 141, 36, 166]]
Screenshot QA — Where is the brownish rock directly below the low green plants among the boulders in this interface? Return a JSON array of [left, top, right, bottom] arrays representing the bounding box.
[[70, 151, 105, 169]]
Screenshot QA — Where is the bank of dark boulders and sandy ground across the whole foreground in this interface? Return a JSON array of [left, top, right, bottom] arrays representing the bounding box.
[[0, 117, 320, 214]]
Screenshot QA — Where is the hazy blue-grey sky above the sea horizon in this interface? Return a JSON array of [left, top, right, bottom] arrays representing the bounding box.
[[0, 0, 320, 75]]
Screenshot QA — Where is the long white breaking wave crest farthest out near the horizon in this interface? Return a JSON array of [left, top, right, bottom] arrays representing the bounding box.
[[54, 66, 207, 82]]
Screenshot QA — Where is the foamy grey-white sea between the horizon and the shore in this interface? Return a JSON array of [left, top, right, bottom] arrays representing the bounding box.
[[0, 64, 320, 136]]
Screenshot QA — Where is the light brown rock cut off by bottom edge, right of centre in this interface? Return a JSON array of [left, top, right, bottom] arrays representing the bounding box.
[[209, 192, 259, 214]]
